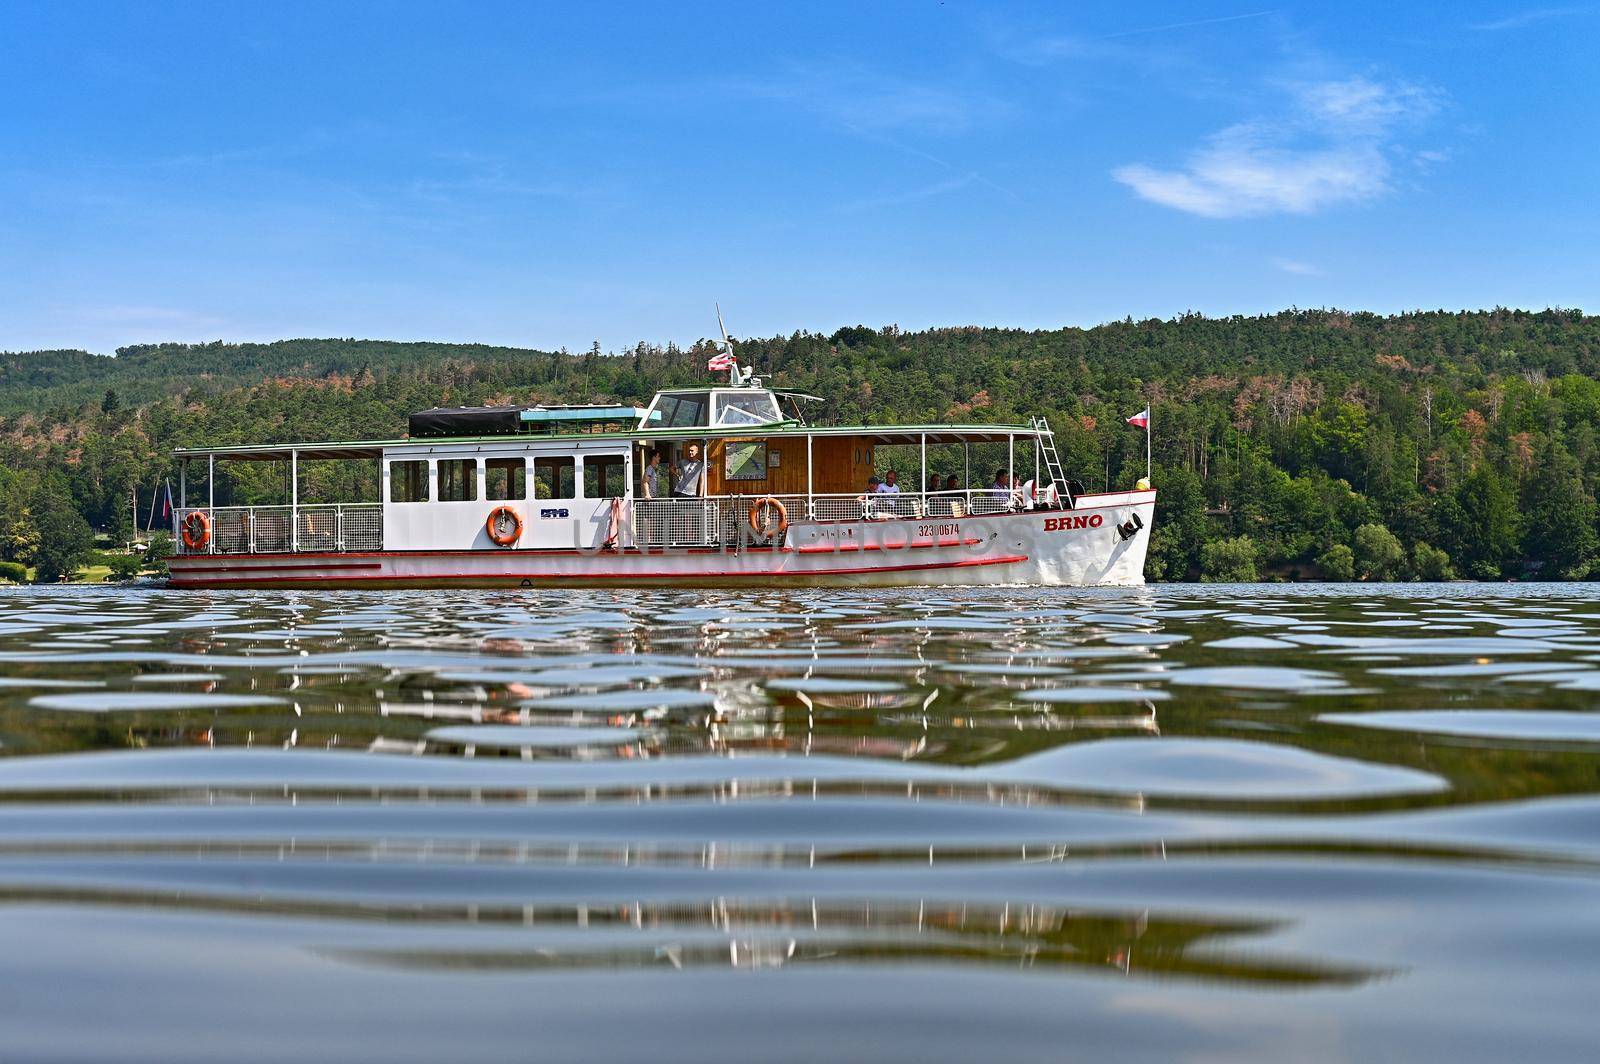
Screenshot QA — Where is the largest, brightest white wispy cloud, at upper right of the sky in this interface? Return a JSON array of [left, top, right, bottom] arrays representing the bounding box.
[[1112, 77, 1440, 218]]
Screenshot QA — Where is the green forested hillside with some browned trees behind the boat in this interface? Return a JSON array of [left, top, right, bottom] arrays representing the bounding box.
[[0, 310, 1600, 579]]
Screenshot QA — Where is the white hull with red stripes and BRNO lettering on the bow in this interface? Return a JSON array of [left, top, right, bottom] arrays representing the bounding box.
[[170, 491, 1155, 589]]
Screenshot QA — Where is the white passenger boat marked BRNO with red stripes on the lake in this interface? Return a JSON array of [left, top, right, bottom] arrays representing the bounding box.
[[170, 336, 1155, 589]]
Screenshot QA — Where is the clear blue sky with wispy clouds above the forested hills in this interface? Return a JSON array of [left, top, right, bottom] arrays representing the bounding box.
[[0, 0, 1600, 352]]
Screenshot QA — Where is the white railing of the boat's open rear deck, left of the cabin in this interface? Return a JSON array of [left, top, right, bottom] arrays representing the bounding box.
[[173, 502, 384, 554]]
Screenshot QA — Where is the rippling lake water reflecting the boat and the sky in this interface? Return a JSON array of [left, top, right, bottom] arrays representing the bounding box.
[[0, 584, 1600, 1064]]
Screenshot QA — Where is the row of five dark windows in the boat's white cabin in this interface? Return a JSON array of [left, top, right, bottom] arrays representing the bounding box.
[[389, 454, 627, 502]]
